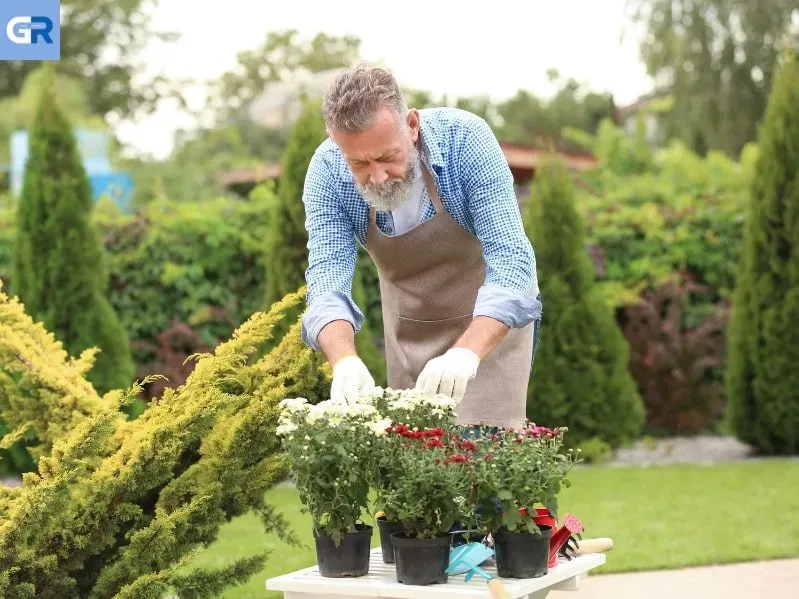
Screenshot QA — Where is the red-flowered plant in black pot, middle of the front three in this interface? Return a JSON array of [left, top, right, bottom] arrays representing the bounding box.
[[381, 424, 473, 585]]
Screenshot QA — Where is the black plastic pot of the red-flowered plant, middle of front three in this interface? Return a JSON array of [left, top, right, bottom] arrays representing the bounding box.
[[391, 532, 450, 586]]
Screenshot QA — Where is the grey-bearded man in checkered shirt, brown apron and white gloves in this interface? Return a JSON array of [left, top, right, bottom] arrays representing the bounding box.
[[302, 65, 542, 427]]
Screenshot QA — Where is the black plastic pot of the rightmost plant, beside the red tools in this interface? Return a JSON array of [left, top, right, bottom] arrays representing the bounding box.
[[494, 524, 552, 578]]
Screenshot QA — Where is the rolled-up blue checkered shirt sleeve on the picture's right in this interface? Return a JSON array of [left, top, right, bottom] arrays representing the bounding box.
[[460, 118, 542, 328]]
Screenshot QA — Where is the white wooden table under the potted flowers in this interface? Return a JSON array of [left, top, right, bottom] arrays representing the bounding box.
[[266, 547, 605, 599]]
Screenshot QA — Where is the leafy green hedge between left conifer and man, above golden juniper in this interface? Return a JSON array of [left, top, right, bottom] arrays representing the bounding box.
[[94, 195, 274, 394]]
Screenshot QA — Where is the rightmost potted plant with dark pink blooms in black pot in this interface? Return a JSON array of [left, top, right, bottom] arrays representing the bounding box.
[[474, 424, 576, 578]]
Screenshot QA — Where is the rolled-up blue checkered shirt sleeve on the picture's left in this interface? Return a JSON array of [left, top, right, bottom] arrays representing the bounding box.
[[302, 150, 364, 351]]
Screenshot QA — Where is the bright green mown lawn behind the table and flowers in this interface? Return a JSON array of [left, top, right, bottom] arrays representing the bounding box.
[[184, 460, 799, 599]]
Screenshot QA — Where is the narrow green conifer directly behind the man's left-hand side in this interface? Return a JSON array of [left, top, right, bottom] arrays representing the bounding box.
[[266, 99, 385, 381]]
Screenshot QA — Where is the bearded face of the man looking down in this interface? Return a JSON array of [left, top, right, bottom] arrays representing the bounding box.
[[330, 108, 421, 210]]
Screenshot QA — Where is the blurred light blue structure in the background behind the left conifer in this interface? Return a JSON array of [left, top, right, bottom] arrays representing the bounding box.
[[10, 129, 133, 213]]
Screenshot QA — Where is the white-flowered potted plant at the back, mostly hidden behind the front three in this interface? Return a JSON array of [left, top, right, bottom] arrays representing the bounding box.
[[359, 387, 455, 564]]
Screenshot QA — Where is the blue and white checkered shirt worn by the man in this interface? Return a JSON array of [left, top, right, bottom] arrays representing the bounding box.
[[302, 107, 542, 350]]
